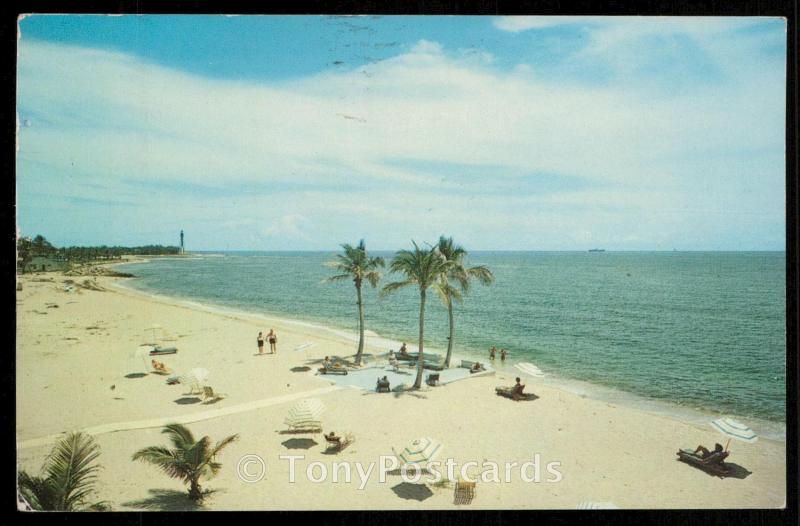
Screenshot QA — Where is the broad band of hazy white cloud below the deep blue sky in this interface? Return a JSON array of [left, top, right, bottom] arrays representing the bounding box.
[[18, 24, 783, 252]]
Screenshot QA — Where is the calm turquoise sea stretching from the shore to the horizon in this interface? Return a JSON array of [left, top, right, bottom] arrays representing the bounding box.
[[115, 252, 786, 428]]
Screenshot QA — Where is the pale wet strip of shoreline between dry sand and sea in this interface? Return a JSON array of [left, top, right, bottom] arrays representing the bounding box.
[[110, 272, 786, 444]]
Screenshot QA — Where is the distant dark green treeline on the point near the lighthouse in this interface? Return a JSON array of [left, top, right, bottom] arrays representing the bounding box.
[[17, 235, 180, 268]]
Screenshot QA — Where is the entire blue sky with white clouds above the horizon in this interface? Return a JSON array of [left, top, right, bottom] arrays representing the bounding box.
[[16, 15, 786, 250]]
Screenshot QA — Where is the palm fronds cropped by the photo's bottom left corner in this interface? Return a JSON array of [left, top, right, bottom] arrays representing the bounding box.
[[18, 432, 109, 511]]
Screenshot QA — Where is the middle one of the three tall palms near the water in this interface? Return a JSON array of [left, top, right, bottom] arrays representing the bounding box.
[[382, 241, 450, 389]]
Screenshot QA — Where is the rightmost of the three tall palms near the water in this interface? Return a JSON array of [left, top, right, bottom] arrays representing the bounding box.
[[436, 236, 494, 367]]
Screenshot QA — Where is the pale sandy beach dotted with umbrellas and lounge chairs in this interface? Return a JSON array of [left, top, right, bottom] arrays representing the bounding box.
[[16, 273, 786, 510]]
